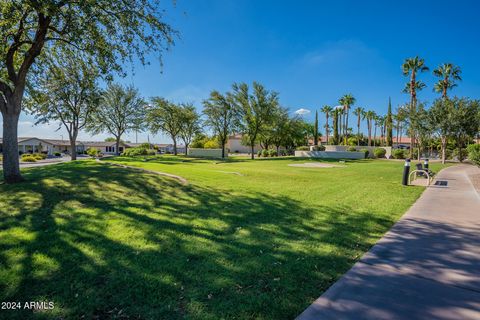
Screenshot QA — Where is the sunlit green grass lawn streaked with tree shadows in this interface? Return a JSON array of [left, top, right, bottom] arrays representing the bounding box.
[[0, 156, 446, 320]]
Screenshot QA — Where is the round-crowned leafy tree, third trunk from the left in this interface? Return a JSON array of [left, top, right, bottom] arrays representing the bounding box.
[[87, 84, 146, 155]]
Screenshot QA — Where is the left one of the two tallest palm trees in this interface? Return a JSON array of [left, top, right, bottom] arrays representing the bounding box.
[[402, 56, 429, 157]]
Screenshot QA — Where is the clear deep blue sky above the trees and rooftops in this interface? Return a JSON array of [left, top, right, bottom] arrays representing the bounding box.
[[9, 0, 480, 142]]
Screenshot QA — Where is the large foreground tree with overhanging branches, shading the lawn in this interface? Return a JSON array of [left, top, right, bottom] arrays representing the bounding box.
[[0, 0, 176, 183]]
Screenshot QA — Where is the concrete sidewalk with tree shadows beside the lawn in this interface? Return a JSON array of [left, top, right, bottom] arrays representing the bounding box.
[[297, 165, 480, 320]]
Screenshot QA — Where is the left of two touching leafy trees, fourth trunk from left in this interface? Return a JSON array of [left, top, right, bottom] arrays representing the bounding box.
[[147, 97, 184, 155]]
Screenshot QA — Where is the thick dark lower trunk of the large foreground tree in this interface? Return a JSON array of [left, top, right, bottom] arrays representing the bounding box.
[[2, 111, 23, 183]]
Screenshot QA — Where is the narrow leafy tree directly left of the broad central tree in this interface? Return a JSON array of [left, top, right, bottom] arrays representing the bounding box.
[[203, 91, 235, 158]]
